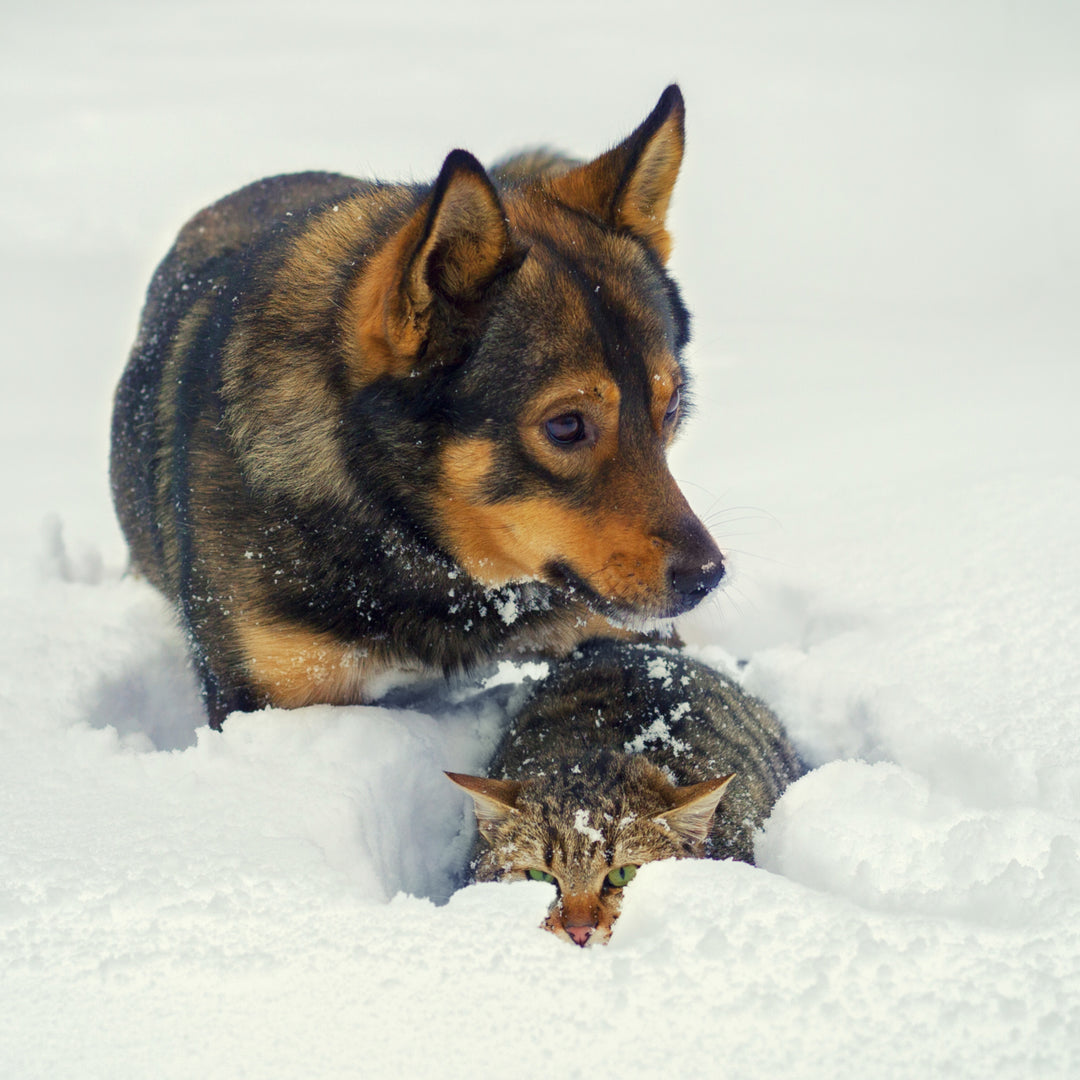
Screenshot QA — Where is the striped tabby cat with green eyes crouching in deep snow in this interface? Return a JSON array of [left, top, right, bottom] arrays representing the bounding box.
[[447, 640, 807, 947]]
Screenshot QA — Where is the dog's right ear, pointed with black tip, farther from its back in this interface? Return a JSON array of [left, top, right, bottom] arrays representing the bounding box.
[[549, 83, 686, 262]]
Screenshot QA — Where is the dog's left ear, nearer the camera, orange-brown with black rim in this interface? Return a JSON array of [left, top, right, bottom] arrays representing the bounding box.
[[352, 150, 526, 381]]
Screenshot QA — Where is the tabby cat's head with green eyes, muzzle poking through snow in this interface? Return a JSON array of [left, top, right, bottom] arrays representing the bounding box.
[[447, 751, 731, 947]]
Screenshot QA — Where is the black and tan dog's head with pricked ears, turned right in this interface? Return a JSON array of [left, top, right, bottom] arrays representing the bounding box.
[[350, 86, 724, 620]]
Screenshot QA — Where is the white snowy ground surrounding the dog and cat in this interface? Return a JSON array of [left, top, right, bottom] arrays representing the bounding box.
[[0, 0, 1080, 1080]]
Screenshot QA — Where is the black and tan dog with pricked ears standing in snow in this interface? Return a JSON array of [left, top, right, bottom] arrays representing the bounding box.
[[110, 85, 724, 728]]
